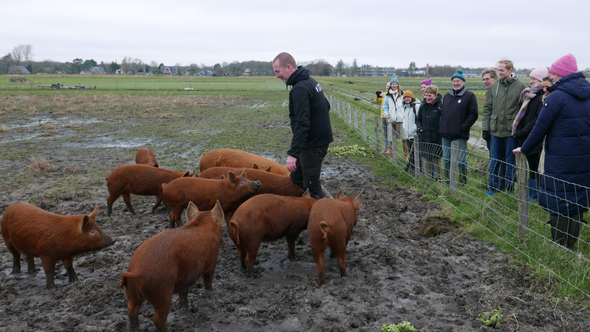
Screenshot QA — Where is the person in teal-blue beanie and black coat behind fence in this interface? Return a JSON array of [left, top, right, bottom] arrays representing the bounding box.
[[439, 70, 479, 185]]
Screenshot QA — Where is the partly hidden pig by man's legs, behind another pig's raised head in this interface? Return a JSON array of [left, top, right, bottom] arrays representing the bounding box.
[[199, 167, 304, 197]]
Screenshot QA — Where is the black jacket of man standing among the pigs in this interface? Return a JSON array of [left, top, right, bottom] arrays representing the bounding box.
[[287, 66, 334, 158]]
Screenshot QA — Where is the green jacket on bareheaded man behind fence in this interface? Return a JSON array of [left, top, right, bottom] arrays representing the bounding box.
[[481, 76, 527, 137]]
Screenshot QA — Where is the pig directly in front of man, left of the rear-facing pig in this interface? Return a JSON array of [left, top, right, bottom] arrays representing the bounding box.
[[227, 191, 316, 277]]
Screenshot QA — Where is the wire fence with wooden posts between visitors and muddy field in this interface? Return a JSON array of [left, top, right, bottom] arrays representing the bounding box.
[[328, 95, 590, 297]]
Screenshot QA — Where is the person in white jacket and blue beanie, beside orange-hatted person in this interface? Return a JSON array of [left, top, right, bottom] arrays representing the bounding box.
[[383, 74, 408, 159]]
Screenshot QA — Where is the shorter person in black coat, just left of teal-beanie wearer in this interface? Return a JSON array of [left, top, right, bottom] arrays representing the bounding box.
[[416, 85, 442, 181]]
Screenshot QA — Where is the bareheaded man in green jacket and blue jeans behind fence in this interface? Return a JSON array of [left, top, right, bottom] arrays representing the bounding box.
[[481, 59, 527, 196]]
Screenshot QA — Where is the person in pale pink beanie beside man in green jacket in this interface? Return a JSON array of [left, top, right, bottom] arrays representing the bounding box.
[[512, 67, 549, 203]]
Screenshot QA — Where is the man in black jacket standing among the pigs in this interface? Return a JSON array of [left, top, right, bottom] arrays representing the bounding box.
[[272, 52, 334, 199]]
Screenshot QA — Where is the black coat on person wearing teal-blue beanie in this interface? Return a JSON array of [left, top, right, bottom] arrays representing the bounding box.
[[439, 87, 478, 139]]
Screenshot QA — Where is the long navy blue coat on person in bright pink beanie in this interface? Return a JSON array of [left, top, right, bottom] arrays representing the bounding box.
[[521, 73, 590, 215]]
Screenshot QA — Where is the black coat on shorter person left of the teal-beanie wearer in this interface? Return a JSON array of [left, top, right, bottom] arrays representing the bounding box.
[[416, 93, 442, 158]]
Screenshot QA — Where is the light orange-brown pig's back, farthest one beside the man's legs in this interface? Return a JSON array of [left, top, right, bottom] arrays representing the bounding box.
[[199, 149, 291, 175]]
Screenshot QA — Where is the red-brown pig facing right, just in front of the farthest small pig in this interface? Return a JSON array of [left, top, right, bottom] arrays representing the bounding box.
[[106, 164, 195, 216]]
